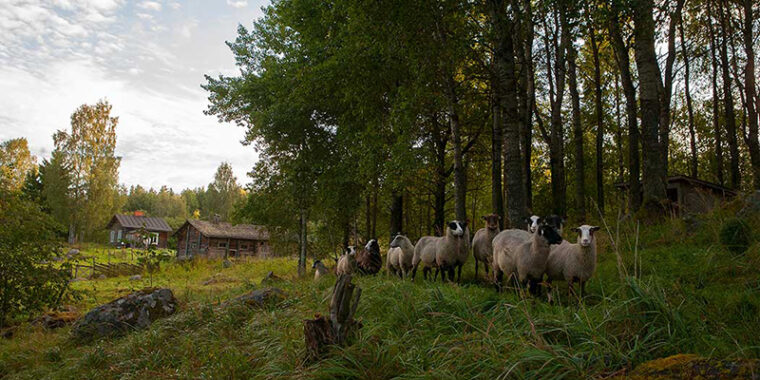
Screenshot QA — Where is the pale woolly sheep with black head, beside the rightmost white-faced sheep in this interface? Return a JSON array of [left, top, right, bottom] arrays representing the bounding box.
[[493, 223, 562, 294]]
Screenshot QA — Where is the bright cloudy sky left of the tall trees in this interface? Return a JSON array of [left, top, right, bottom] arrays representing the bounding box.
[[0, 0, 268, 190]]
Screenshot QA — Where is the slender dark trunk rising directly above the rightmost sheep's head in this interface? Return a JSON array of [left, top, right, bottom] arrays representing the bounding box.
[[567, 44, 586, 221]]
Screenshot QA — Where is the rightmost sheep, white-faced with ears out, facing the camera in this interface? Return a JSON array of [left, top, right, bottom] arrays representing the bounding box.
[[546, 224, 599, 300]]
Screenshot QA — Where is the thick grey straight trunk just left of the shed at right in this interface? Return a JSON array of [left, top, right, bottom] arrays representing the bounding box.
[[633, 0, 667, 212]]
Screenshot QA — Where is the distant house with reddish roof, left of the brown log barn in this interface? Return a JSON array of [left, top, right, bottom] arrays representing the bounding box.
[[106, 211, 172, 248]]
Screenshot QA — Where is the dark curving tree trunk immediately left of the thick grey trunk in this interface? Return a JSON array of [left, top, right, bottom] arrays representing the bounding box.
[[609, 12, 641, 212]]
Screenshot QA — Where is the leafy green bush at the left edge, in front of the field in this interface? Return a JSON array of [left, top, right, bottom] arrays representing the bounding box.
[[0, 190, 71, 326]]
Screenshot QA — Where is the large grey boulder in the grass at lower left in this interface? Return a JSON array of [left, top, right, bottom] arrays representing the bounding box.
[[71, 288, 177, 341]]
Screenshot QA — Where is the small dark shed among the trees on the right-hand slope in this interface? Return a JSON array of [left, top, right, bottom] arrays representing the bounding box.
[[615, 175, 738, 214]]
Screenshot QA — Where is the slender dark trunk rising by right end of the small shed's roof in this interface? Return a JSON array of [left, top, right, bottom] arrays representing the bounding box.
[[718, 1, 741, 189]]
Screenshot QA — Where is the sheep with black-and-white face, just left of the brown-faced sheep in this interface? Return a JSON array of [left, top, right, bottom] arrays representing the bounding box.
[[412, 220, 470, 281]]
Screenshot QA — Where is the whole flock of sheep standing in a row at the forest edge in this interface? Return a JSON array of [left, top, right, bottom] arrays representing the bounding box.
[[312, 214, 599, 300]]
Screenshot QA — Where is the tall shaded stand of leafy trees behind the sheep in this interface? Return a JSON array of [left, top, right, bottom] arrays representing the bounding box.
[[204, 0, 760, 265]]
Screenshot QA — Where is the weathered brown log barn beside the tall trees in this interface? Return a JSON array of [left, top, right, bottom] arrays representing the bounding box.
[[173, 219, 269, 259]]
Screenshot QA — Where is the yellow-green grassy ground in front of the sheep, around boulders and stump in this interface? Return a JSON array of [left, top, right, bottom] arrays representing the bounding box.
[[0, 215, 760, 380]]
